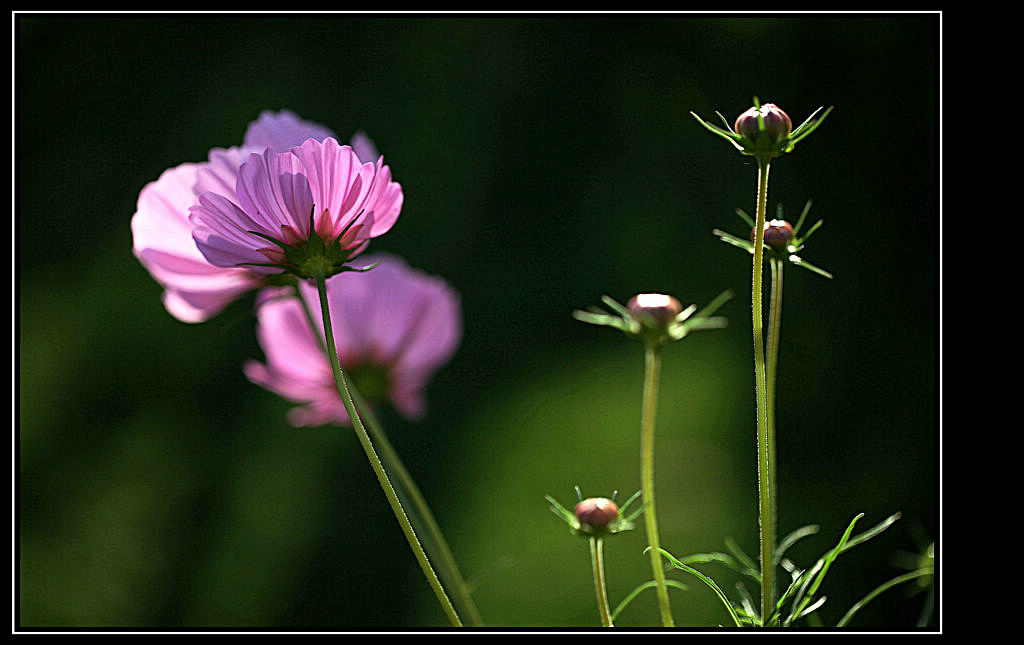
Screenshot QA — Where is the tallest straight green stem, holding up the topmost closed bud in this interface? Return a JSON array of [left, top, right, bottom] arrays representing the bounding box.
[[751, 157, 775, 620]]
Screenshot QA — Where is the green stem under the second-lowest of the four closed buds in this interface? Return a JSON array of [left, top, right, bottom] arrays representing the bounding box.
[[640, 342, 675, 627]]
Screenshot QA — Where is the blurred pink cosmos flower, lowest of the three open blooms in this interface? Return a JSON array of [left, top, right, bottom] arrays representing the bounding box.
[[244, 254, 462, 426]]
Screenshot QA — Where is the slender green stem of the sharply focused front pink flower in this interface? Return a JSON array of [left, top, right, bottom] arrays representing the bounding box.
[[315, 275, 462, 627]]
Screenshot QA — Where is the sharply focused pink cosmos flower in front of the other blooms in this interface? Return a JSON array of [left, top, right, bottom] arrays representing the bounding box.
[[188, 137, 402, 277]]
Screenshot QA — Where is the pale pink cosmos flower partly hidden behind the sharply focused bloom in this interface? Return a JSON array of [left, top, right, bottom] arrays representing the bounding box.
[[131, 110, 378, 323]]
